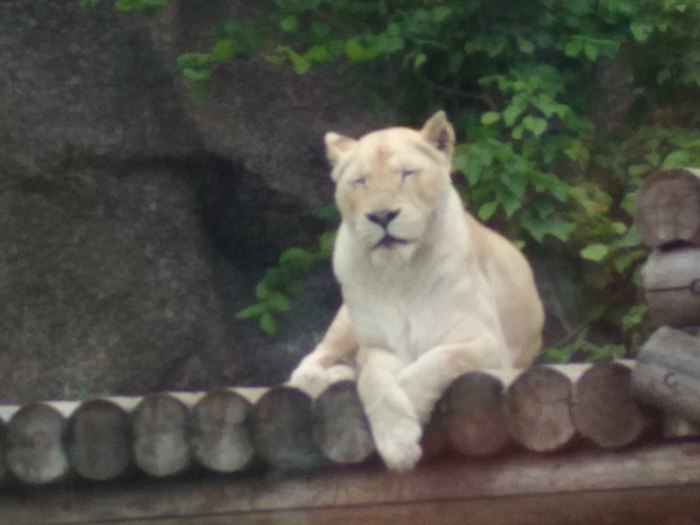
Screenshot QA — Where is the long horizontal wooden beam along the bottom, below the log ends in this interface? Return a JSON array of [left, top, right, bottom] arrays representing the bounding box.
[[0, 443, 700, 525]]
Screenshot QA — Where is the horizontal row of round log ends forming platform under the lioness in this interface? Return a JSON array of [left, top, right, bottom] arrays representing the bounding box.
[[0, 363, 696, 484]]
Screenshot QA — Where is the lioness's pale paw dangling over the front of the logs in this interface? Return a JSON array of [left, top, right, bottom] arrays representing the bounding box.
[[374, 418, 422, 472]]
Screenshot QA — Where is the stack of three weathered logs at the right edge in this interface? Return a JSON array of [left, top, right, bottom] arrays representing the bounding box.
[[633, 169, 700, 422]]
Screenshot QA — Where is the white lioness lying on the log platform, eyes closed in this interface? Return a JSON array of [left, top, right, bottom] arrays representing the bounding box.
[[290, 111, 544, 471]]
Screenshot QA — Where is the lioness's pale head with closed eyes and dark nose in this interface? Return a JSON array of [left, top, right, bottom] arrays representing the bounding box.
[[325, 111, 455, 259]]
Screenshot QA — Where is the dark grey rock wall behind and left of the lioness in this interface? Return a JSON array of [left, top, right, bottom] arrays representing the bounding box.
[[0, 0, 386, 402]]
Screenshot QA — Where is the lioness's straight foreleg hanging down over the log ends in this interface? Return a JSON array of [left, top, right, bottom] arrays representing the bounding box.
[[357, 348, 422, 471]]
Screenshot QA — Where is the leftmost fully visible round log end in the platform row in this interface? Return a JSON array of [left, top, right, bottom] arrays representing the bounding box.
[[7, 403, 69, 484]]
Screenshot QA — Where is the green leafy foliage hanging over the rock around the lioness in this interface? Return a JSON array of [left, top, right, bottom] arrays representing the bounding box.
[[84, 0, 700, 360]]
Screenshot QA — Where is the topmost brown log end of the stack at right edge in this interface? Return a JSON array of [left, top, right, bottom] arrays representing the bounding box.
[[635, 169, 700, 248]]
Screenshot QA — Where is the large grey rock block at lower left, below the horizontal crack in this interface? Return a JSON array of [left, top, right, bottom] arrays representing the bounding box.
[[0, 169, 235, 401]]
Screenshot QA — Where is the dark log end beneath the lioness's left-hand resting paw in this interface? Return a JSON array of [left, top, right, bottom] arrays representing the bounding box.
[[252, 386, 324, 470]]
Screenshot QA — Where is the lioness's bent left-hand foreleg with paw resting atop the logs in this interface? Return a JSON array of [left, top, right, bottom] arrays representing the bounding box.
[[288, 306, 357, 397]]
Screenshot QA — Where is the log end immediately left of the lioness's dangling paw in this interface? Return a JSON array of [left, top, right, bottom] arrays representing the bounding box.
[[314, 381, 374, 464]]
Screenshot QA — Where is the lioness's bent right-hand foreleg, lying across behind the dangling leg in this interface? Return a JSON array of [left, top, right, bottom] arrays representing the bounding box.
[[398, 341, 509, 424]]
